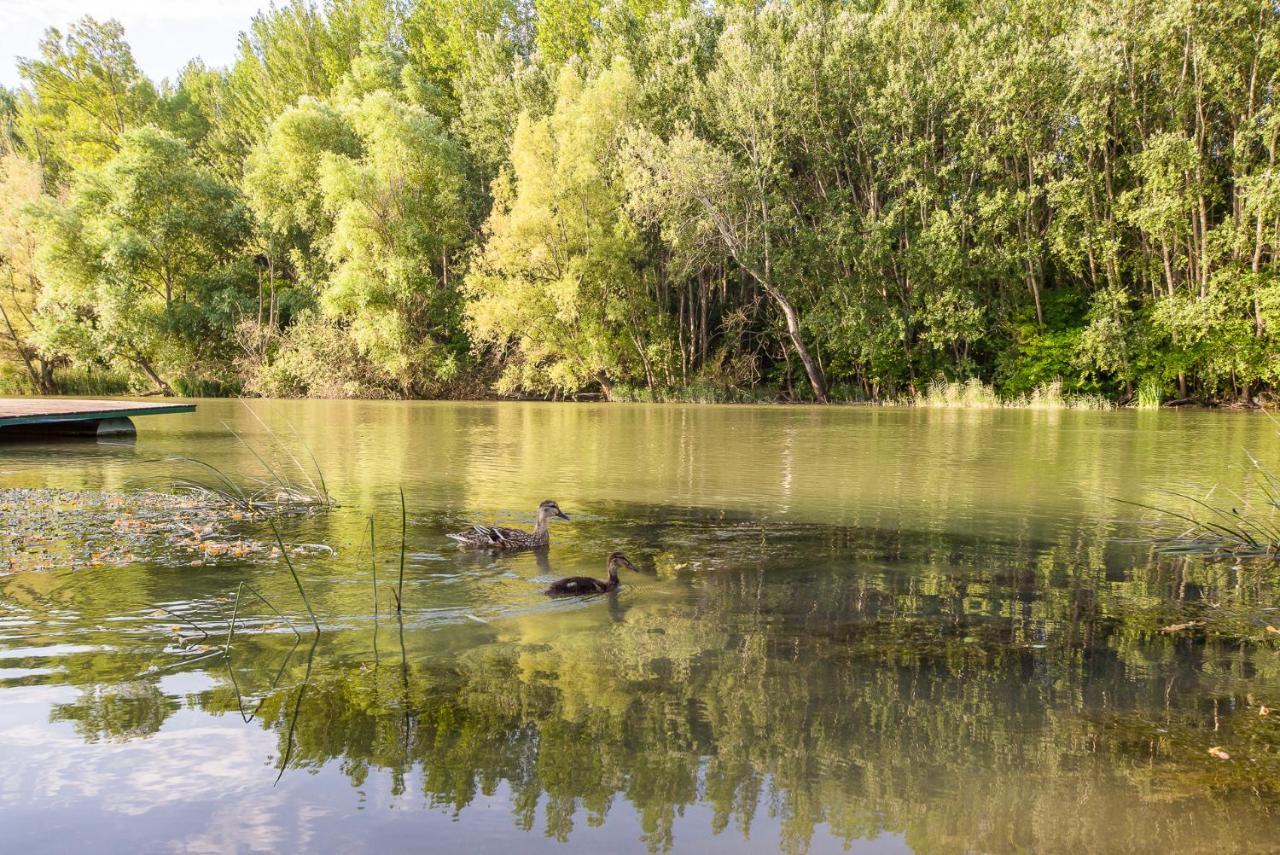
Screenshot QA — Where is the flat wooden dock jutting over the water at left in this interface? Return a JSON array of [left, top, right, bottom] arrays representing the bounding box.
[[0, 398, 196, 440]]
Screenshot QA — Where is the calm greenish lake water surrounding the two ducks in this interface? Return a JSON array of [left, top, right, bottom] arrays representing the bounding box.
[[0, 401, 1280, 852]]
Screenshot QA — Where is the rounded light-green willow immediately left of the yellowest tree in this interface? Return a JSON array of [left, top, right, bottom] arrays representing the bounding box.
[[320, 91, 471, 394]]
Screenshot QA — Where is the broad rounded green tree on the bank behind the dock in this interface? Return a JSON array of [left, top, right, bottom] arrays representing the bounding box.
[[30, 127, 248, 394]]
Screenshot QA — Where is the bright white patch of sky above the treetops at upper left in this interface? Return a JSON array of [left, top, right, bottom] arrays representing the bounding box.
[[0, 0, 270, 87]]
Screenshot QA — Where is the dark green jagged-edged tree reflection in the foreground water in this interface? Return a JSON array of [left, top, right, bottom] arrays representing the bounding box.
[[22, 513, 1280, 851]]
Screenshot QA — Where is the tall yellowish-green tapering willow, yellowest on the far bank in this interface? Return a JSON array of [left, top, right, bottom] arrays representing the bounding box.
[[465, 61, 669, 394]]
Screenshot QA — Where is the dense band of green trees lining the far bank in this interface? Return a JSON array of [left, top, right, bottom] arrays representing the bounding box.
[[0, 0, 1280, 402]]
